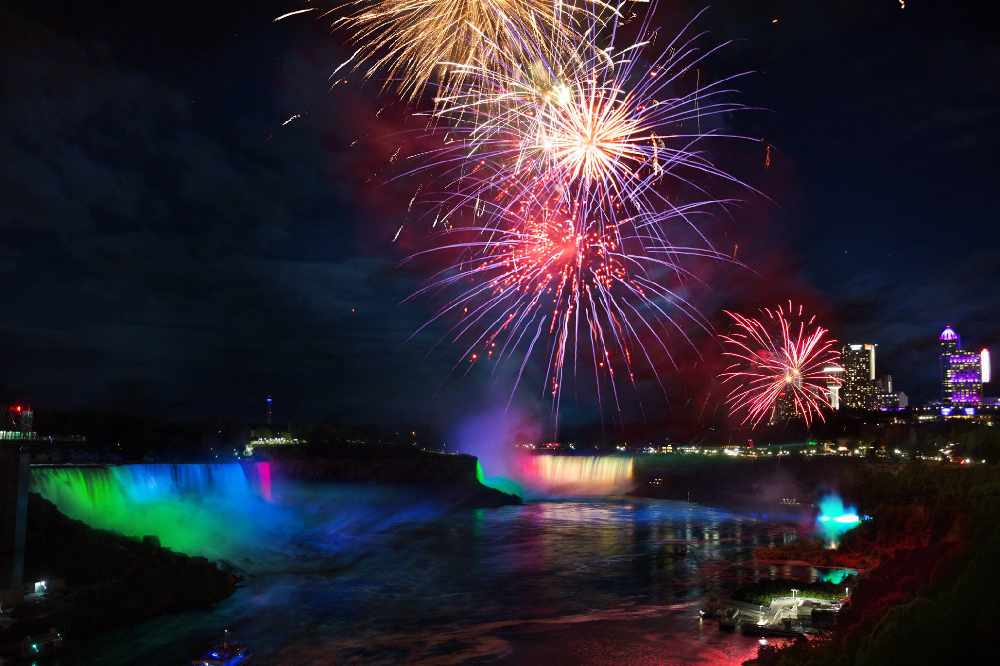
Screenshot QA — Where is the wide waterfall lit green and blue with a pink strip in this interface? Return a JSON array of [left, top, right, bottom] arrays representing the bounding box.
[[31, 462, 447, 571]]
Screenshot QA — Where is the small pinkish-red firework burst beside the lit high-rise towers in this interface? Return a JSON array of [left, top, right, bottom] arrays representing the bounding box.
[[720, 301, 840, 427]]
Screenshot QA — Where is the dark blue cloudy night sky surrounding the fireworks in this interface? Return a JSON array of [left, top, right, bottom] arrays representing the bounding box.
[[0, 0, 1000, 424]]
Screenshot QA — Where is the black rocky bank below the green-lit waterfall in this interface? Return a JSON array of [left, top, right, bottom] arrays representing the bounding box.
[[0, 493, 237, 651]]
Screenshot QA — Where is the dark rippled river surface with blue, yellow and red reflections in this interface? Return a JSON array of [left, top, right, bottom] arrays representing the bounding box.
[[86, 495, 815, 665]]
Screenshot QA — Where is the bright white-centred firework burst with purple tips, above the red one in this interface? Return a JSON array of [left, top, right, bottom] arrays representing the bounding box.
[[403, 3, 755, 260]]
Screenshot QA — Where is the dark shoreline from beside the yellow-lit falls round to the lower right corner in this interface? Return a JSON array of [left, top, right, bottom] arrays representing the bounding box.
[[634, 456, 1000, 666]]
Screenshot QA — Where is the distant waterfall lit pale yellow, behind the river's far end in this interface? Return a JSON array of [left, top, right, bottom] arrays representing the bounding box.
[[522, 455, 634, 496]]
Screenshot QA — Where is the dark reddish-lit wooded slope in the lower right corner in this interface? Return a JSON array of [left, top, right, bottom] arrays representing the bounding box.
[[748, 463, 1000, 666]]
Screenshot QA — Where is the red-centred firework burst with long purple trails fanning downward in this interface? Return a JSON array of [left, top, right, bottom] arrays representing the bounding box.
[[411, 192, 727, 418]]
